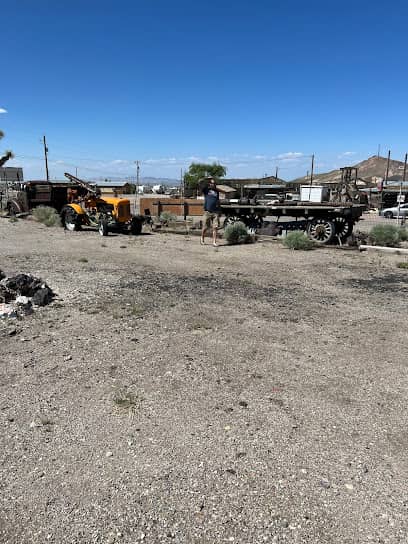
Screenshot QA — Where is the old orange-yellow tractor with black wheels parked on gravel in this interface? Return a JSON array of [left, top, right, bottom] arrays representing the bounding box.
[[61, 173, 144, 236]]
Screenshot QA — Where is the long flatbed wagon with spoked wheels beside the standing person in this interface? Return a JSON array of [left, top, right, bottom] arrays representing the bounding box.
[[221, 202, 367, 244]]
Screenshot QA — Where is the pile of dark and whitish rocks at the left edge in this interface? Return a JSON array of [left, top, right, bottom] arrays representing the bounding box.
[[0, 270, 55, 318]]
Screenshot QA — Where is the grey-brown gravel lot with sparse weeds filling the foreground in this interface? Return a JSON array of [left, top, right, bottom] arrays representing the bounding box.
[[0, 219, 408, 544]]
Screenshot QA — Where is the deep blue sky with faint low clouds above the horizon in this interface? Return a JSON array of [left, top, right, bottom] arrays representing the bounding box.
[[0, 0, 408, 179]]
